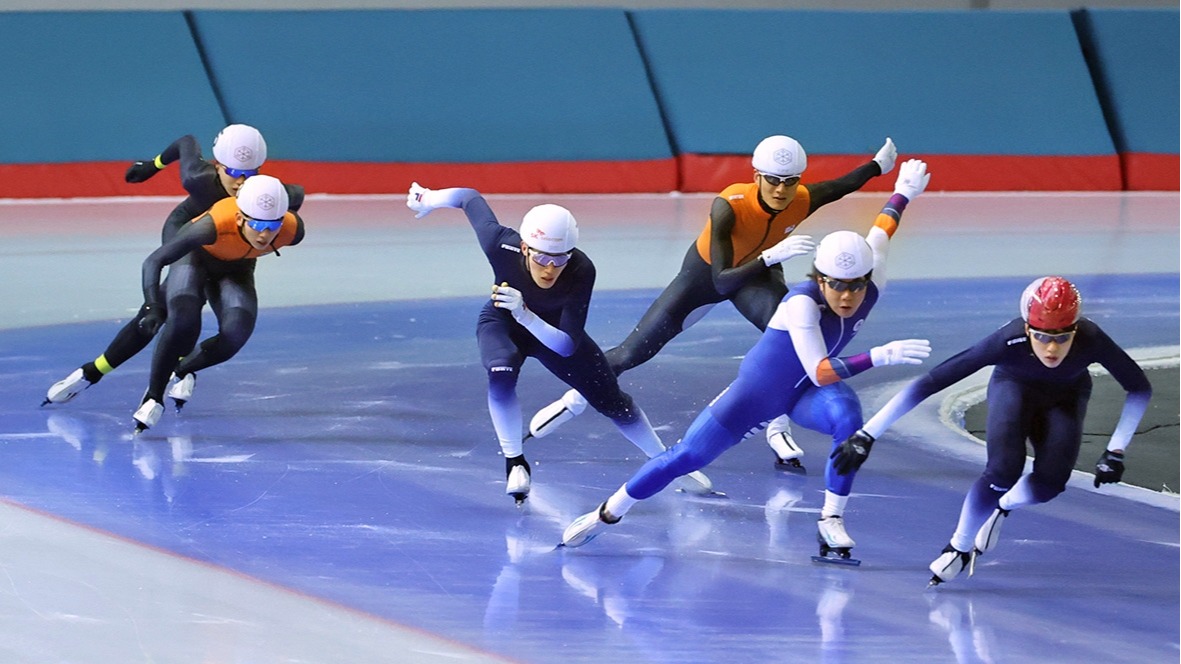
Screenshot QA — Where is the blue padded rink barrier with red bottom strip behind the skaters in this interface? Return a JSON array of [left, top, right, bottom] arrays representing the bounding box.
[[0, 9, 1179, 197]]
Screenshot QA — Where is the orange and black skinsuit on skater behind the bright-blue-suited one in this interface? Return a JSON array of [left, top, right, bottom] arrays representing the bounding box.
[[607, 161, 881, 376]]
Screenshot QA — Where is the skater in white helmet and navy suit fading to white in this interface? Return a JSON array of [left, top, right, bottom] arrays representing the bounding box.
[[406, 182, 710, 504]]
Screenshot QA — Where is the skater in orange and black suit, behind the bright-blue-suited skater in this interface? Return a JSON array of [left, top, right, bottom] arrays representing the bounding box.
[[529, 135, 898, 471]]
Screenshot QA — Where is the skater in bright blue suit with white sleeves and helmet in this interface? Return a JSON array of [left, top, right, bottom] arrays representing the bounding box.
[[562, 160, 931, 559]]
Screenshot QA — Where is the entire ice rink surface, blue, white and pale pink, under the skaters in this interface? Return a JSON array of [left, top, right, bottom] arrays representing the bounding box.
[[0, 189, 1181, 664]]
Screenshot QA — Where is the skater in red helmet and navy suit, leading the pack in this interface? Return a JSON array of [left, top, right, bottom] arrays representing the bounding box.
[[834, 276, 1153, 585]]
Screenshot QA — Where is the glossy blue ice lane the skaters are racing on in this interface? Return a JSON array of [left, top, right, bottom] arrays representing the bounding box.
[[0, 275, 1181, 662]]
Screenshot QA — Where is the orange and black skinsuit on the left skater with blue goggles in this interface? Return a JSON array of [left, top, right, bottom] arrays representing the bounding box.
[[143, 198, 304, 403]]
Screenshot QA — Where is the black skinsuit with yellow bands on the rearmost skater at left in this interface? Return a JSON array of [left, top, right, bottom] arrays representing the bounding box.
[[74, 135, 304, 383]]
